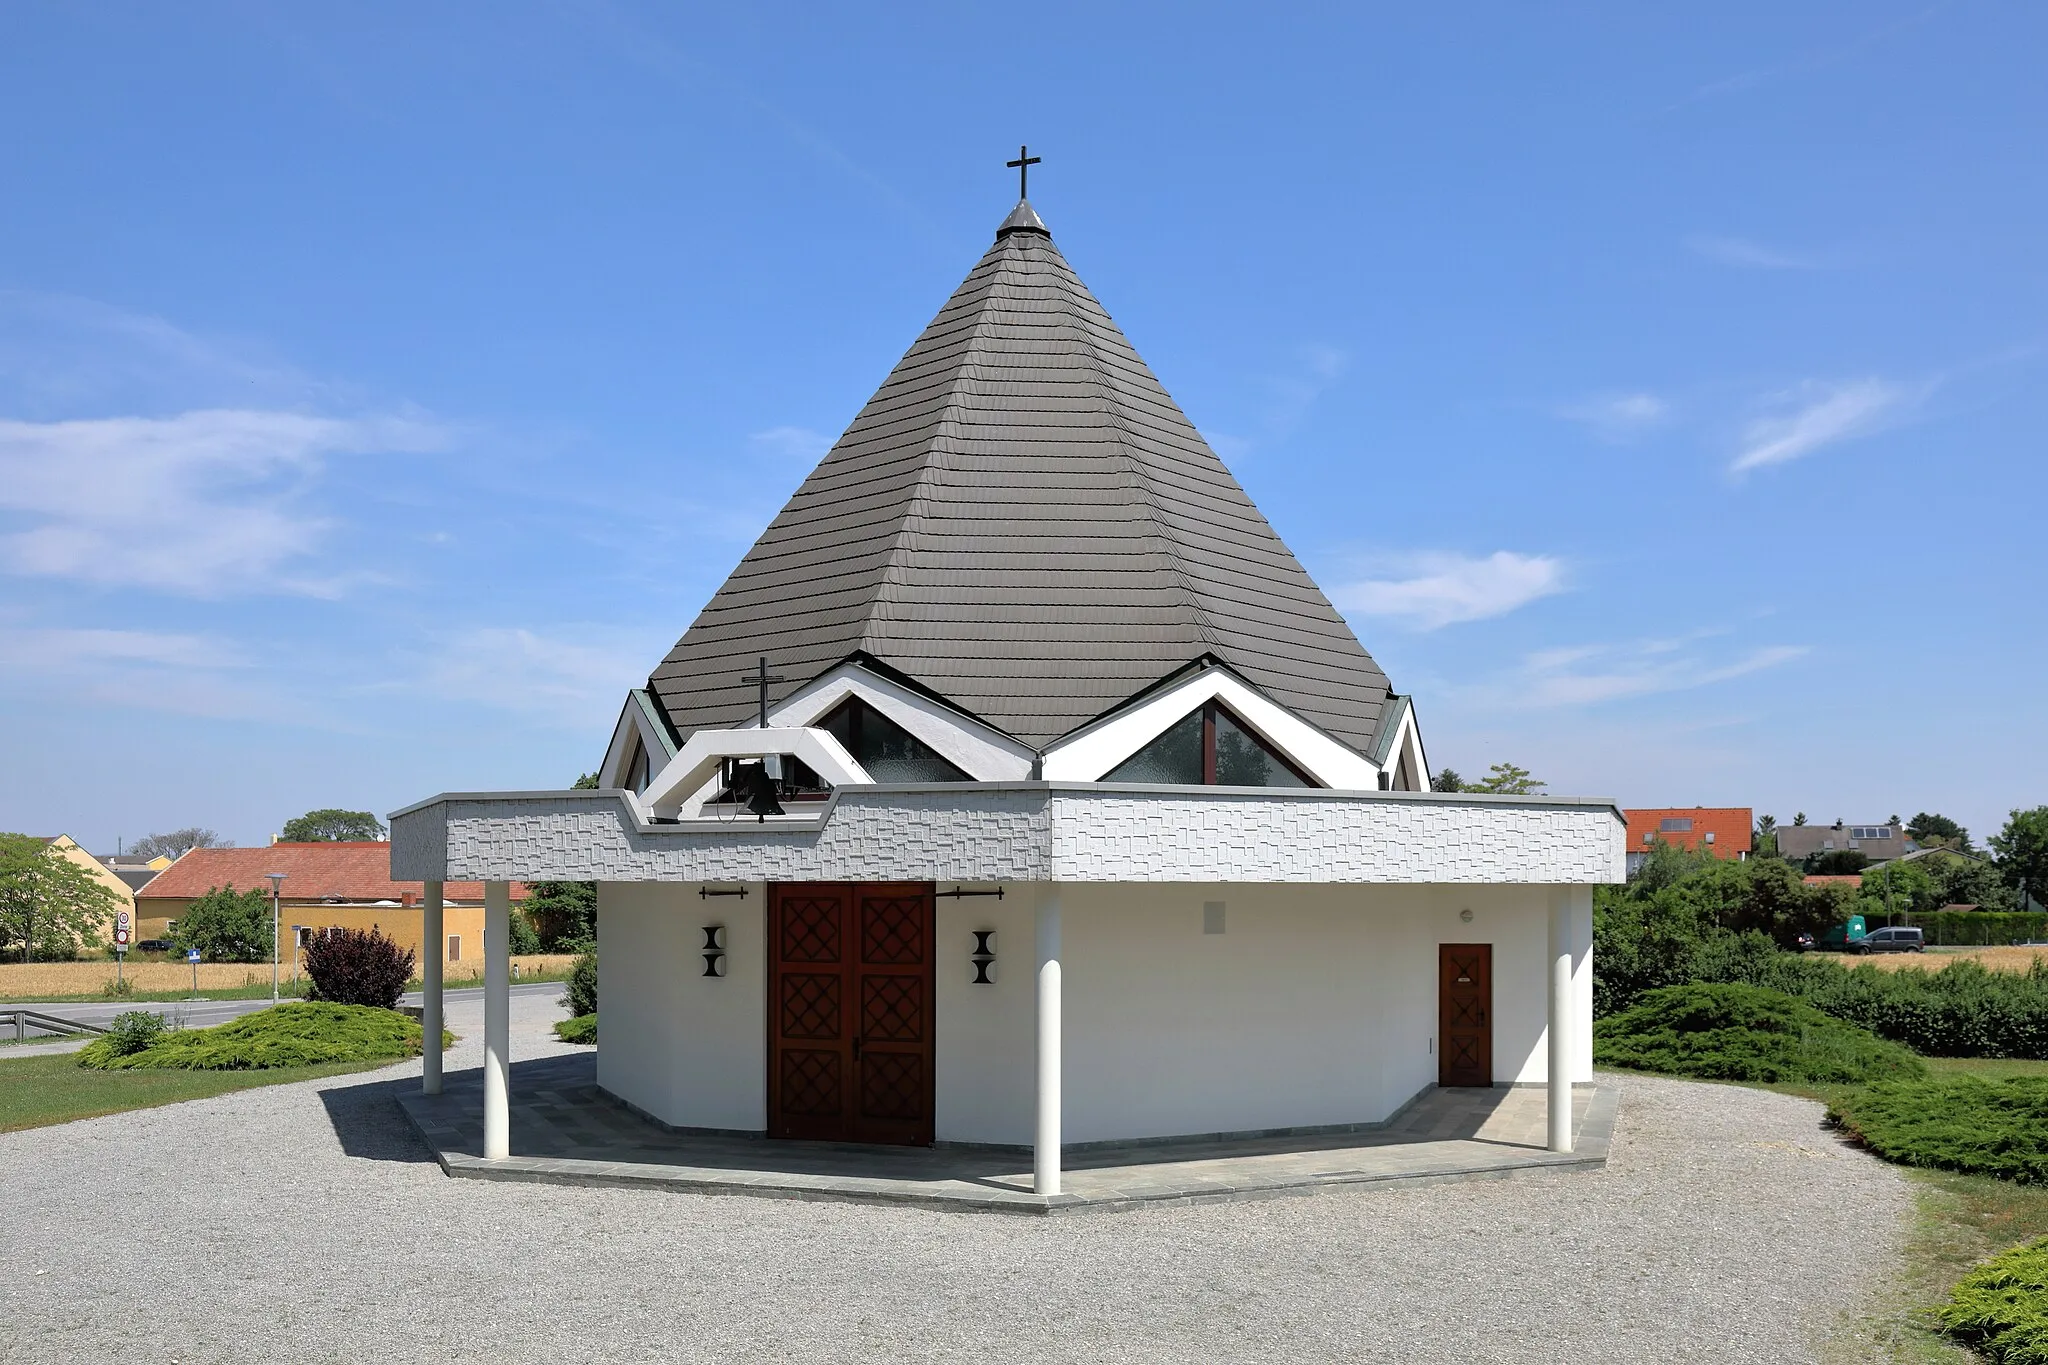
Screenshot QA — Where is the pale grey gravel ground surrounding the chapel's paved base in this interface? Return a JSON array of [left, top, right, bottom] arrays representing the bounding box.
[[0, 999, 1909, 1365]]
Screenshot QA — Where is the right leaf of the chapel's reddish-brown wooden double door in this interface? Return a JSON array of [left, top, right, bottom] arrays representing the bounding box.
[[850, 884, 936, 1146]]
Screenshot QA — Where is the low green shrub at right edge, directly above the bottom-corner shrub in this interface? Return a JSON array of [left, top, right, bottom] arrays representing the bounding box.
[[1827, 1076, 2048, 1185]]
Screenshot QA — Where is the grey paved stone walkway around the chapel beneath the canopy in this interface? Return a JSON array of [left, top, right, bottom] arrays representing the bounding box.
[[399, 1054, 1618, 1214]]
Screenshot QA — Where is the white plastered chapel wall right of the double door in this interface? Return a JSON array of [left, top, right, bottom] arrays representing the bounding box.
[[936, 884, 1591, 1144]]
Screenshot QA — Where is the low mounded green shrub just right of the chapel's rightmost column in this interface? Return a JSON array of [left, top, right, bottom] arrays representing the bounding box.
[[1593, 984, 1927, 1083]]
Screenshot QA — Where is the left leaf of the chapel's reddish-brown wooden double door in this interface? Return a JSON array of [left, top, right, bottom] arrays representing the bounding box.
[[768, 882, 856, 1142]]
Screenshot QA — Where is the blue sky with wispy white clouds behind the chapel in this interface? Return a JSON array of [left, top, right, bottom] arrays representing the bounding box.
[[0, 2, 2048, 847]]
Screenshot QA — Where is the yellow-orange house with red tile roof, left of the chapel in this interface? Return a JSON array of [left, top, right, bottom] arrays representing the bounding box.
[[135, 841, 526, 964]]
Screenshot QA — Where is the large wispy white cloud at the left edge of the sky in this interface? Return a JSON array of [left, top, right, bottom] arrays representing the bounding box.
[[0, 409, 451, 596]]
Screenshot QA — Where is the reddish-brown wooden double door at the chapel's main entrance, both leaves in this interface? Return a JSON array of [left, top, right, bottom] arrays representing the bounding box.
[[768, 882, 934, 1146]]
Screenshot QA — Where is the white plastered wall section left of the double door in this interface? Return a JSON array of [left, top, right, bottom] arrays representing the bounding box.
[[598, 882, 768, 1132]]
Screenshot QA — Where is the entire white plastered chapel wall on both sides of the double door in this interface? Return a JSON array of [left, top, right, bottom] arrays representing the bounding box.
[[598, 882, 1593, 1144]]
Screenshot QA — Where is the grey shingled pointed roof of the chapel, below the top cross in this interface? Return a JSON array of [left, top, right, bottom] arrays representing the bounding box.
[[649, 203, 1389, 749]]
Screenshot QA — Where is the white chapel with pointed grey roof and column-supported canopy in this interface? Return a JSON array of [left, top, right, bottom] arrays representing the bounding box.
[[391, 184, 1624, 1193]]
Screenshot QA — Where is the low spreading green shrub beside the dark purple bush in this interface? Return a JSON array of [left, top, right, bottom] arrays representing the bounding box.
[[78, 1001, 428, 1070]]
